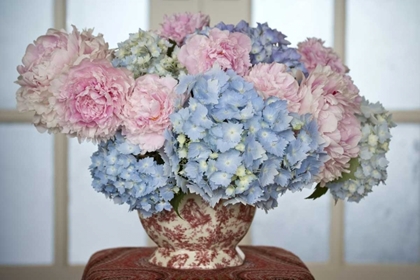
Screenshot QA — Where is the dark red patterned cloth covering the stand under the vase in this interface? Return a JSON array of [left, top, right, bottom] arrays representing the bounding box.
[[82, 246, 314, 280]]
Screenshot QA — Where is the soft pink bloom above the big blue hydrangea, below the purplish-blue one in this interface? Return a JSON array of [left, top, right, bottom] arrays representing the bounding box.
[[245, 63, 302, 112]]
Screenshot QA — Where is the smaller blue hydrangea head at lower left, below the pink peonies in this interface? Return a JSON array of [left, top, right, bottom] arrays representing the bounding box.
[[89, 133, 177, 217]]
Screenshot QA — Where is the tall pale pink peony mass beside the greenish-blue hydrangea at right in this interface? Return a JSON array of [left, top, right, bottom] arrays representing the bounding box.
[[298, 66, 361, 186]]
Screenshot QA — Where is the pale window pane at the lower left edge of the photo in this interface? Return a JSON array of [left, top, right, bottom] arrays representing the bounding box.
[[0, 124, 54, 265]]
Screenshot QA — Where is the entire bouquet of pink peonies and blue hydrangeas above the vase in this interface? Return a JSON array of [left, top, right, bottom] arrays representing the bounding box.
[[17, 13, 395, 217]]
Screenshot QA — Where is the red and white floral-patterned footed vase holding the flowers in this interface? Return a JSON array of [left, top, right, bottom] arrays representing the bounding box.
[[139, 194, 255, 269]]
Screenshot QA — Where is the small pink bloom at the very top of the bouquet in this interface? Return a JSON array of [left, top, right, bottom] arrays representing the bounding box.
[[158, 12, 210, 45]]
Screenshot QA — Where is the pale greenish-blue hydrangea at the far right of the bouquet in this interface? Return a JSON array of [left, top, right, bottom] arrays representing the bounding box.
[[327, 98, 395, 202]]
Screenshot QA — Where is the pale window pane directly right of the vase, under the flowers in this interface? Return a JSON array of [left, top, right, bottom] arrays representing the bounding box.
[[251, 189, 331, 262]]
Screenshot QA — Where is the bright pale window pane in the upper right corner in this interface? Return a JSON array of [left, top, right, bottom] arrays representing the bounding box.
[[346, 0, 420, 110]]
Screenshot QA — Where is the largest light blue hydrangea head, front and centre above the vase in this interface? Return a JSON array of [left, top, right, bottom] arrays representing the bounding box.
[[165, 67, 324, 210]]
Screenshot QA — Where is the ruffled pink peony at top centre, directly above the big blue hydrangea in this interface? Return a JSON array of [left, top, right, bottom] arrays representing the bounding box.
[[178, 28, 251, 76]]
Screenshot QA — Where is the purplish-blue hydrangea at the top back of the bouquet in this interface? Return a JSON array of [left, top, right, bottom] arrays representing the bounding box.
[[215, 20, 308, 75]]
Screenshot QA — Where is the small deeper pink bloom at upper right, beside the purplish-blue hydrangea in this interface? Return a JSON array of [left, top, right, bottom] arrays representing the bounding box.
[[298, 38, 348, 74]]
